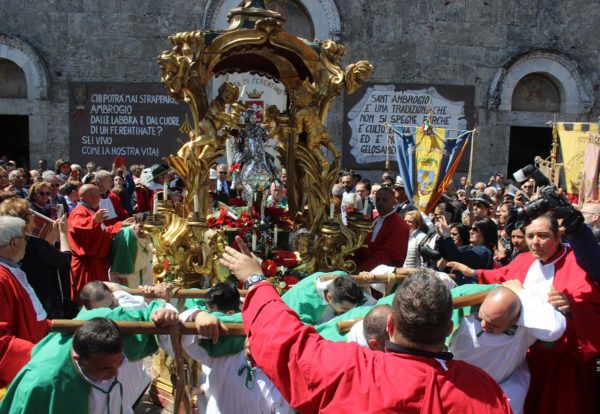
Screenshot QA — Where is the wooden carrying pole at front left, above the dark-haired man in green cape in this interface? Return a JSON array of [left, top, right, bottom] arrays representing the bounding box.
[[50, 319, 246, 336]]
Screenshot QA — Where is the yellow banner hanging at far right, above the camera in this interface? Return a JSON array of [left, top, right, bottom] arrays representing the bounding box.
[[556, 122, 598, 194]]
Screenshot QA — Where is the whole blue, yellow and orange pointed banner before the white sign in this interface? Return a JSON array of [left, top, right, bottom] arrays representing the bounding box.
[[392, 125, 473, 214]]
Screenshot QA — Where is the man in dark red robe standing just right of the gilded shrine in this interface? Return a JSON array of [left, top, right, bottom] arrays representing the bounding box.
[[356, 187, 409, 272]]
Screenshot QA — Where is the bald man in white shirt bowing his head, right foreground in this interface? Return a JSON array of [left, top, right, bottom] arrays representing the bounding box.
[[449, 280, 566, 413]]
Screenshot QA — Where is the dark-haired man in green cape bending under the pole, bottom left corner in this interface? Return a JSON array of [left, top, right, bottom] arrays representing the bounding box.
[[0, 301, 178, 414]]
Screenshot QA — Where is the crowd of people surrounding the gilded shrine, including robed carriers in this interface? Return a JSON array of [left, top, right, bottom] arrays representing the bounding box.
[[0, 154, 600, 413]]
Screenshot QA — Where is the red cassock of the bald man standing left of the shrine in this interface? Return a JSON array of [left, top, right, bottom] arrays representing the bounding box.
[[67, 204, 123, 300]]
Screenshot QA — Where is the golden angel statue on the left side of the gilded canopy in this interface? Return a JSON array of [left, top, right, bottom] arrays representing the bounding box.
[[177, 81, 244, 161]]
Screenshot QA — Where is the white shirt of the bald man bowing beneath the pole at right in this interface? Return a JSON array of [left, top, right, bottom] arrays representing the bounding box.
[[449, 289, 567, 413]]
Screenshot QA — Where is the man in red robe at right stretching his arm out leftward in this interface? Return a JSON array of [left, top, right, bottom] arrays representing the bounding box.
[[449, 215, 600, 413]]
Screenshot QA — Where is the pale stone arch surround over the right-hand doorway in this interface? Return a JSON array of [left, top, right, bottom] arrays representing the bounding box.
[[487, 50, 593, 114]]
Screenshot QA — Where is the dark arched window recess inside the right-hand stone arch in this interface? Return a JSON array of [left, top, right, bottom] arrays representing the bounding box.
[[511, 73, 560, 112]]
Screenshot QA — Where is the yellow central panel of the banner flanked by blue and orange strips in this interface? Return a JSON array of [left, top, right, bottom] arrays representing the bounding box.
[[413, 128, 446, 211]]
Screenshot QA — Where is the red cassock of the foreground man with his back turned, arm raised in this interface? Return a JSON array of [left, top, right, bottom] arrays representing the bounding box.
[[242, 282, 511, 414]]
